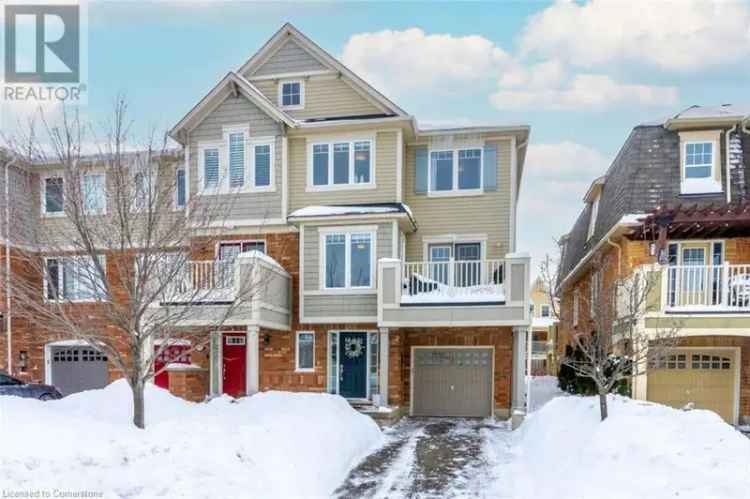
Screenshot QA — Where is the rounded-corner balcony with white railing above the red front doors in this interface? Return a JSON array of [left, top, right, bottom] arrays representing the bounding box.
[[151, 251, 292, 329]]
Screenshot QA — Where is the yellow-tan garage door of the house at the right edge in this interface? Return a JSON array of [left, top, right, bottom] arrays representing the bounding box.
[[647, 349, 737, 423]]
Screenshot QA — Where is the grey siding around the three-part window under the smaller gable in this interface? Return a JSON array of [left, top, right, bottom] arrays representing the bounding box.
[[189, 96, 282, 220]]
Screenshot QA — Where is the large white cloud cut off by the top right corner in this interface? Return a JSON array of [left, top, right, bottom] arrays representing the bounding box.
[[520, 0, 750, 71]]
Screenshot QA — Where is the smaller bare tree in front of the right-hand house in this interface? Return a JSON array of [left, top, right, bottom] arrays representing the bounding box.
[[562, 256, 679, 421]]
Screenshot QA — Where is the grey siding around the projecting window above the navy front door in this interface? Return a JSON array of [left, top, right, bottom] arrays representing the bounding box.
[[302, 221, 393, 318]]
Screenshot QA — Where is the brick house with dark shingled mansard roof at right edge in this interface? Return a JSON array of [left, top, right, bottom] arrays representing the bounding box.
[[558, 105, 750, 423]]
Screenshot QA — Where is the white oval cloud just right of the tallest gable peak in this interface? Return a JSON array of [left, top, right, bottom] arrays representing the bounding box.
[[341, 28, 509, 93]]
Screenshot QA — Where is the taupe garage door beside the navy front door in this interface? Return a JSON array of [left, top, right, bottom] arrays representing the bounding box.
[[412, 348, 493, 417]]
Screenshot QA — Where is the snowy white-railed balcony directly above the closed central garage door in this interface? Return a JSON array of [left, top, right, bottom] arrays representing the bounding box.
[[378, 254, 529, 327]]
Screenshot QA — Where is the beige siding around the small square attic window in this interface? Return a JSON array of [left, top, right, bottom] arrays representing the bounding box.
[[253, 76, 383, 119]]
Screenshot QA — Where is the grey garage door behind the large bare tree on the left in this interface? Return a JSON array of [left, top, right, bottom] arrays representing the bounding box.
[[51, 347, 109, 395]]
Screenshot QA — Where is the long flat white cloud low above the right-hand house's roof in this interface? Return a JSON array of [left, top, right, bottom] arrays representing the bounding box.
[[490, 72, 679, 111]]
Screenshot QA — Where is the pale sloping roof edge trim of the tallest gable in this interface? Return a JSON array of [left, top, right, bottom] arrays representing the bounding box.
[[237, 23, 408, 116]]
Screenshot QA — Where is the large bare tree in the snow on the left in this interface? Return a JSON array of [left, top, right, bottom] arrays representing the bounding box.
[[5, 99, 280, 428]]
